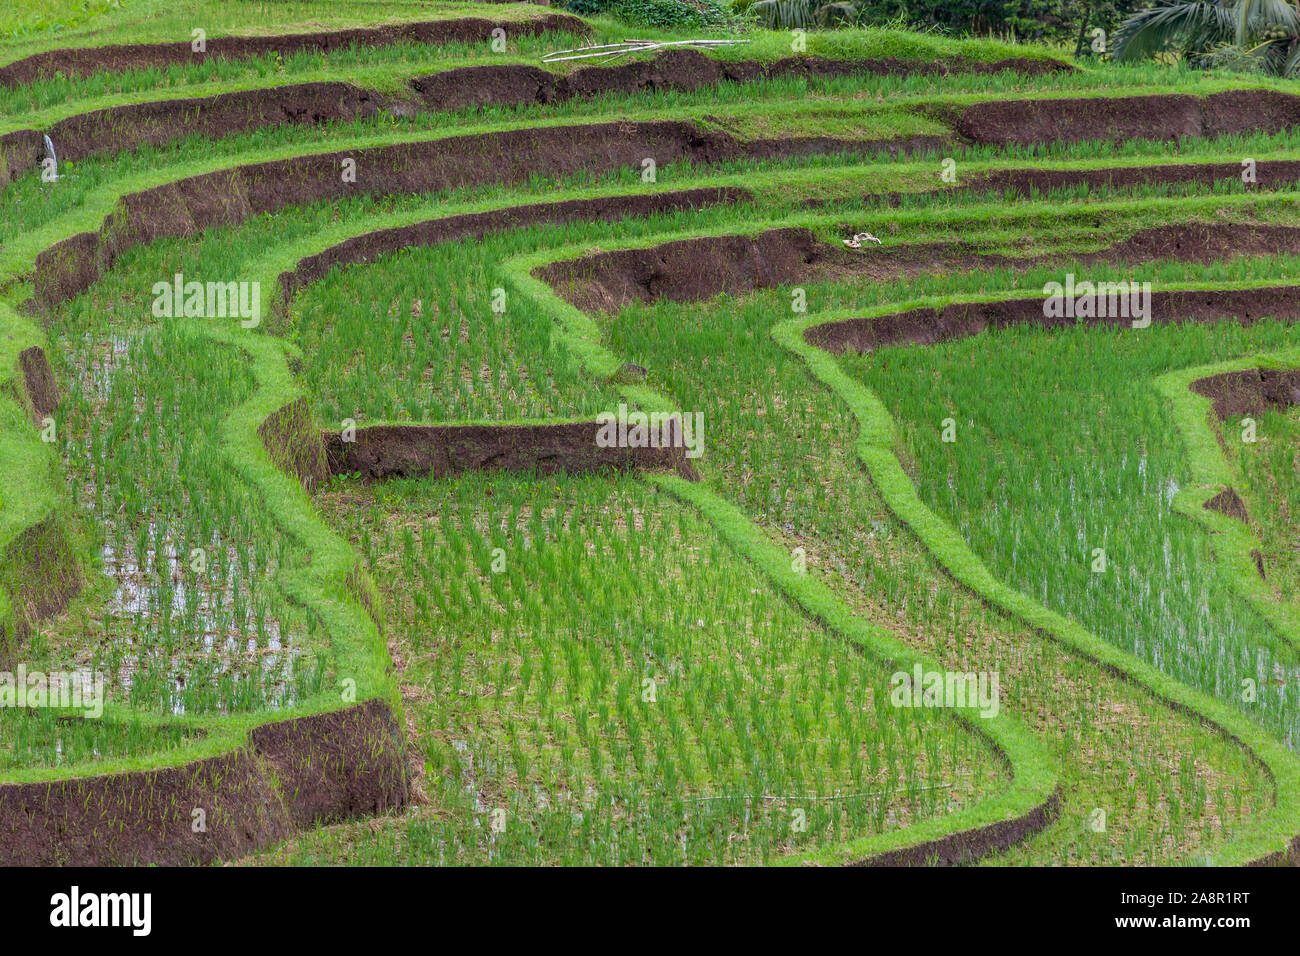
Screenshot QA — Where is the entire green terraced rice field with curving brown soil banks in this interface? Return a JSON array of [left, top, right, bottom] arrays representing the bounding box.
[[0, 0, 1300, 884]]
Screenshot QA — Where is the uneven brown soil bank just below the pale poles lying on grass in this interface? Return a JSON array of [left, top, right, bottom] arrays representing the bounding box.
[[411, 49, 1073, 109]]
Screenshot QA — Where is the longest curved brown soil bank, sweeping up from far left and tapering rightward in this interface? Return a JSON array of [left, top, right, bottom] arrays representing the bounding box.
[[34, 121, 917, 307]]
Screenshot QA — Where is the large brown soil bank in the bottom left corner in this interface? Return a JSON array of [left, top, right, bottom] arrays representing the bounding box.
[[0, 700, 408, 866]]
